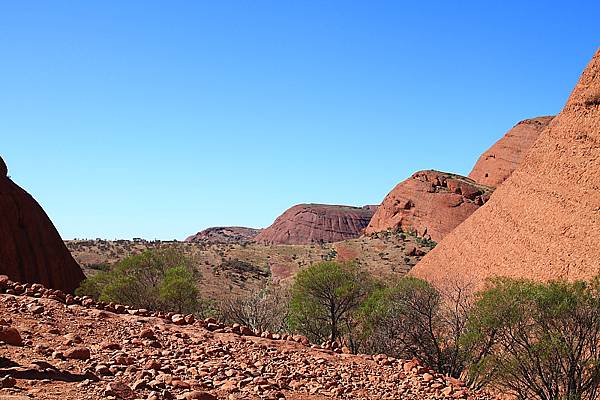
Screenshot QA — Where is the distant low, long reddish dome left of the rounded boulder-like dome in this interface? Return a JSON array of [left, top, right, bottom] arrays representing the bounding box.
[[256, 204, 377, 244]]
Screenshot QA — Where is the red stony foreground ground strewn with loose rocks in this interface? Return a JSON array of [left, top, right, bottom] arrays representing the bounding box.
[[0, 277, 491, 400]]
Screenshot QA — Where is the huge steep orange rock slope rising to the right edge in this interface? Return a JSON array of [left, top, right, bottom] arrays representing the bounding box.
[[411, 51, 600, 287]]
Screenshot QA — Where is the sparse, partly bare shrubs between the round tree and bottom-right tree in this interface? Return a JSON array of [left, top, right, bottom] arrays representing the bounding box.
[[360, 277, 469, 377]]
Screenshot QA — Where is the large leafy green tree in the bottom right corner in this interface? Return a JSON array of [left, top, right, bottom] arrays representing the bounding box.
[[464, 278, 600, 400]]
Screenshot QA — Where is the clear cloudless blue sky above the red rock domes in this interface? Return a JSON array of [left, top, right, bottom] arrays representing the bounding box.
[[0, 0, 600, 239]]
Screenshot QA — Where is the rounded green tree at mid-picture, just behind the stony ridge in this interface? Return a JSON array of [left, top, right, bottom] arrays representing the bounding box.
[[289, 261, 372, 341]]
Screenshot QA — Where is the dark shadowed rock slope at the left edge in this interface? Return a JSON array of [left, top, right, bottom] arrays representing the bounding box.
[[0, 158, 84, 292]]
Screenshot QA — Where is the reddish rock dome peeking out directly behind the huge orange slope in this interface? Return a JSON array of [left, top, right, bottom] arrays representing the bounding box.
[[469, 117, 554, 187]]
